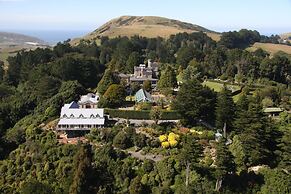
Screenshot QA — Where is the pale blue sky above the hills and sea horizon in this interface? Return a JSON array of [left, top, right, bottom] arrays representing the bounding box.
[[0, 0, 291, 34]]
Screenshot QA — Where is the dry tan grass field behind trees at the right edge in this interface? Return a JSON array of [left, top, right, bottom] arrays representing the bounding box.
[[247, 42, 291, 55]]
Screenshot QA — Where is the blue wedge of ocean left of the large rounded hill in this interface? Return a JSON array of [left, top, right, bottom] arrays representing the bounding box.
[[14, 30, 90, 45]]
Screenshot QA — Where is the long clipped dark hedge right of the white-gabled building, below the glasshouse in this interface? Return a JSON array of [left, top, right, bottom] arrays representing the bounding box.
[[104, 108, 181, 120]]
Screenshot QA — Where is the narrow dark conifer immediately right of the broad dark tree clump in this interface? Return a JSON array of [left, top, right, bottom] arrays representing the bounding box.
[[215, 86, 235, 130]]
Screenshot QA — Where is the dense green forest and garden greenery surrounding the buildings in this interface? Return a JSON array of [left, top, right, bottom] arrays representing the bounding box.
[[0, 30, 291, 194]]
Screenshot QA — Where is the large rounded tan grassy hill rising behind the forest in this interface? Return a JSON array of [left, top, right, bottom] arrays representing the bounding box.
[[73, 16, 220, 43]]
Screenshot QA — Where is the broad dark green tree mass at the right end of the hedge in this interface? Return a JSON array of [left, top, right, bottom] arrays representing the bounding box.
[[173, 79, 216, 125]]
